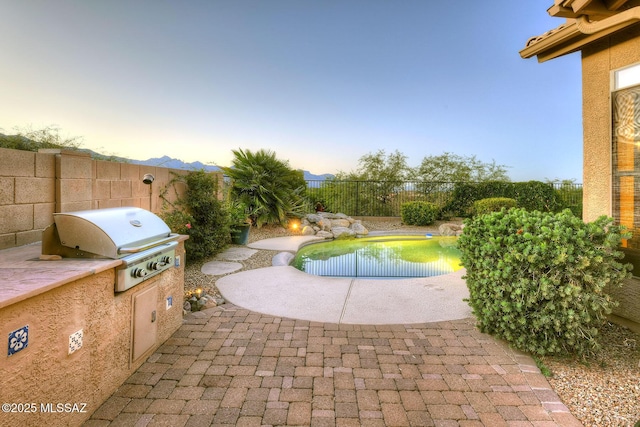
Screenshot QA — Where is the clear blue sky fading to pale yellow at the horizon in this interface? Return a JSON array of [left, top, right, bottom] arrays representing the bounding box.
[[0, 0, 582, 182]]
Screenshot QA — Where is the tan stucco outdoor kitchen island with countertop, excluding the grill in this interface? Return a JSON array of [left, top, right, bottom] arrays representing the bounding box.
[[0, 236, 186, 426]]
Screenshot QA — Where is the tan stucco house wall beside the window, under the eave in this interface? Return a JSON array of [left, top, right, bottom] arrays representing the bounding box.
[[582, 25, 640, 325]]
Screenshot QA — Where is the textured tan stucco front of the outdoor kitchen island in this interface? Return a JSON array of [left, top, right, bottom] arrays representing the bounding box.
[[0, 242, 185, 426]]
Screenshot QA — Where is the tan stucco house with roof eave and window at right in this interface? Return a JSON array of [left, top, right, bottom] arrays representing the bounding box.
[[520, 0, 640, 330]]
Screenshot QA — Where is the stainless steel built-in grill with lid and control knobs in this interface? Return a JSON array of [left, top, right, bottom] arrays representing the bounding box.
[[42, 207, 180, 292]]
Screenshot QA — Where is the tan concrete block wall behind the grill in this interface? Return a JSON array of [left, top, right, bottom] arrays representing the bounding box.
[[0, 148, 222, 249]]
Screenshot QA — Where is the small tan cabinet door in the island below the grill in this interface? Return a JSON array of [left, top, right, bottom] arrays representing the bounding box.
[[131, 286, 158, 362]]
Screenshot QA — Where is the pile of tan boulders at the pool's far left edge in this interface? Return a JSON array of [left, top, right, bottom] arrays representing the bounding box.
[[300, 212, 369, 239]]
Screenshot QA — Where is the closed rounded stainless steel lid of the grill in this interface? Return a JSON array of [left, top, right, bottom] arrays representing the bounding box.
[[43, 207, 179, 258]]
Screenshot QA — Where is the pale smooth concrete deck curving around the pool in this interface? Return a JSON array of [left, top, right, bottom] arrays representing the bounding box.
[[216, 236, 471, 325]]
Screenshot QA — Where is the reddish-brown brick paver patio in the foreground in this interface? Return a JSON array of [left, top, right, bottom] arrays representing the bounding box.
[[85, 304, 581, 427]]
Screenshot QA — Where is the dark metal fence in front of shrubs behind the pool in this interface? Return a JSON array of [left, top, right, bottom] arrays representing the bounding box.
[[307, 180, 582, 217]]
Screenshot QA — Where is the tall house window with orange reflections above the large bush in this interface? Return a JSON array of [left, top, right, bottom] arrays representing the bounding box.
[[611, 64, 640, 276]]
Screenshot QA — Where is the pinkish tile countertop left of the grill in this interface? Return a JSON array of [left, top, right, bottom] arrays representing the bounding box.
[[0, 243, 122, 309]]
